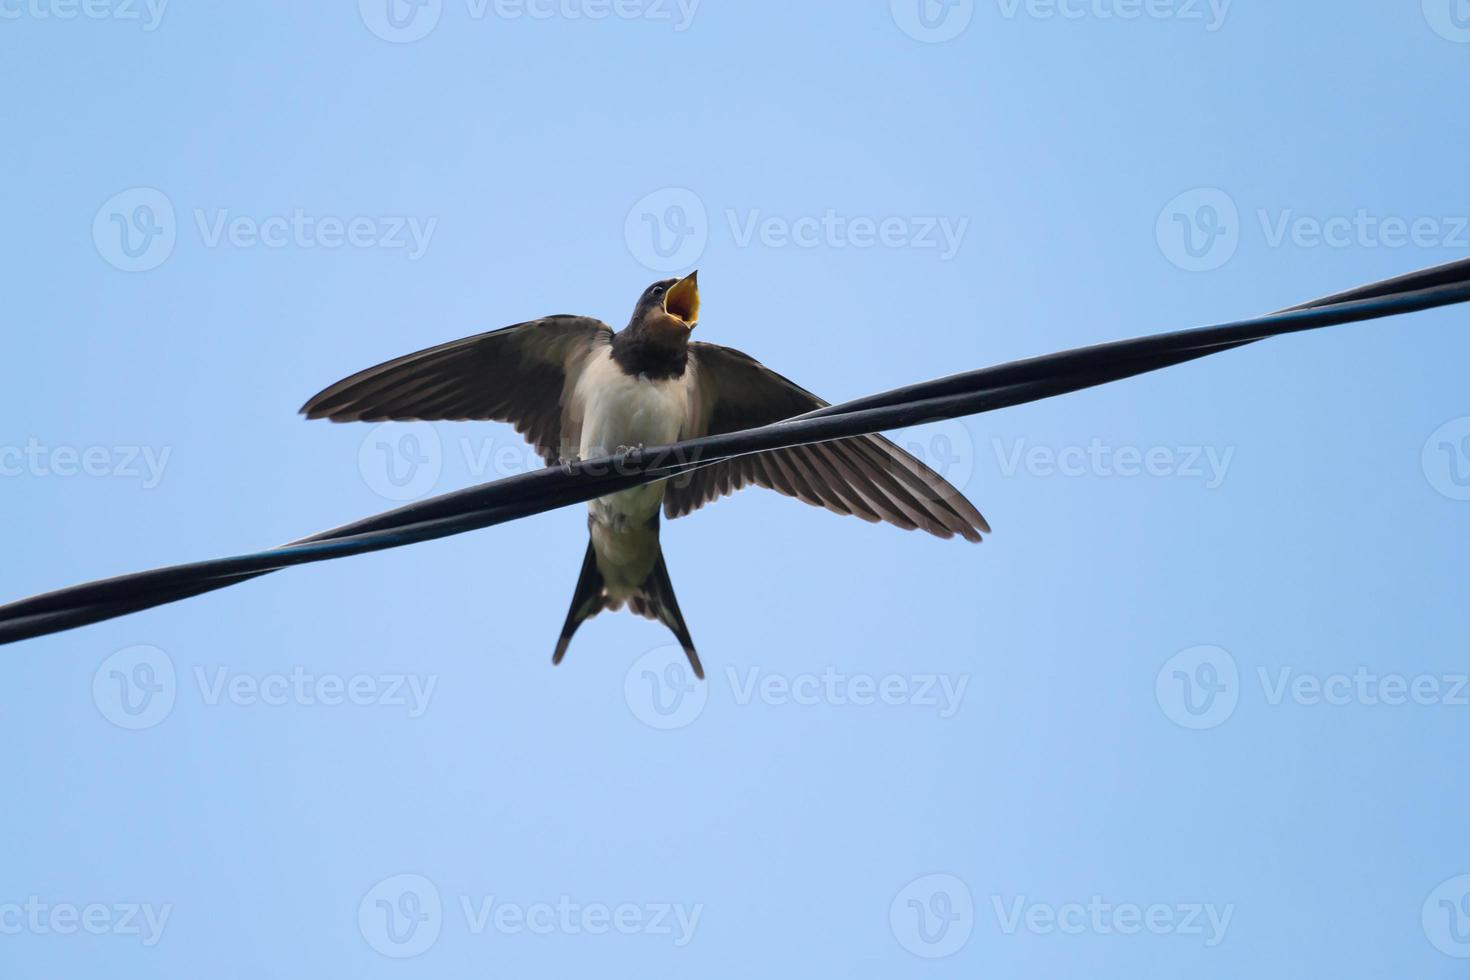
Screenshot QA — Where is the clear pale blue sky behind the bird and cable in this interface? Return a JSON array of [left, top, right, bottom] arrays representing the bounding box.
[[0, 0, 1470, 979]]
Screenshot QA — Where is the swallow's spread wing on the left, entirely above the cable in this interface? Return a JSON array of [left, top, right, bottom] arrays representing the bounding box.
[[301, 316, 613, 464]]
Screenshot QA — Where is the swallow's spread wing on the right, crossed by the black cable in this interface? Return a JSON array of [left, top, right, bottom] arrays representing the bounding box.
[[664, 342, 991, 541]]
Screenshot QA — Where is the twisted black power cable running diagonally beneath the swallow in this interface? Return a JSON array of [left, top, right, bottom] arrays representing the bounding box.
[[0, 260, 1470, 644]]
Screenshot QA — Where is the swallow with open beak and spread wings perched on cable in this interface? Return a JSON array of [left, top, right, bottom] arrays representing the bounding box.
[[301, 270, 991, 679]]
